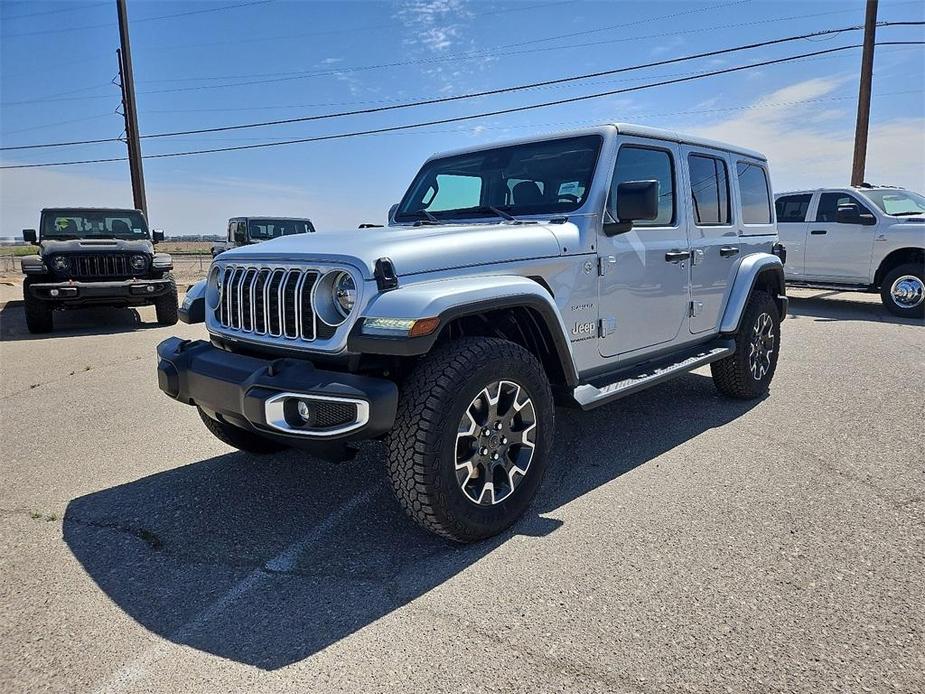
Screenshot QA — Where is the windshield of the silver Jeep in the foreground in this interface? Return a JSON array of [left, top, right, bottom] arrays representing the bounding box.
[[395, 135, 602, 222]]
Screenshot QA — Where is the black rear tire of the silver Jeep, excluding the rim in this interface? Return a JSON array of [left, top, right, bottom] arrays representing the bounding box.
[[710, 291, 780, 400]]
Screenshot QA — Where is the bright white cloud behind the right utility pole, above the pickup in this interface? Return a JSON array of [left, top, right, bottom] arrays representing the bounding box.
[[678, 76, 925, 191]]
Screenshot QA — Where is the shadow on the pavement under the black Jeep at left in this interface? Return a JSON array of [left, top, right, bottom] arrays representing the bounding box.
[[0, 301, 158, 342]]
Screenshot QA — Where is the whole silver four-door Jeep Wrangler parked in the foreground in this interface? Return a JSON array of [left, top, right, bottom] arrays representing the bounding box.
[[157, 125, 787, 542]]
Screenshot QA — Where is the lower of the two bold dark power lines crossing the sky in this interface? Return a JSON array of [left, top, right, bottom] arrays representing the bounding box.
[[0, 41, 925, 169]]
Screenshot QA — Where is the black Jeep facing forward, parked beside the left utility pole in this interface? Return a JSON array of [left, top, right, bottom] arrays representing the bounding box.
[[21, 207, 177, 333]]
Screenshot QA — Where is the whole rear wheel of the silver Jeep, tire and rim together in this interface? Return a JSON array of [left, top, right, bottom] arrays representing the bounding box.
[[710, 291, 780, 400]]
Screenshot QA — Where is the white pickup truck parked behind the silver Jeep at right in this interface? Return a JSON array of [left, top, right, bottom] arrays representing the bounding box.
[[776, 184, 925, 318]]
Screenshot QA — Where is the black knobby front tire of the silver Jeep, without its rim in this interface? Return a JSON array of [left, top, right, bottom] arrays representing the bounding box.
[[386, 337, 555, 542]]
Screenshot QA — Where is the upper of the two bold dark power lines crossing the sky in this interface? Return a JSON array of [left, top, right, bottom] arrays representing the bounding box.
[[0, 22, 925, 151]]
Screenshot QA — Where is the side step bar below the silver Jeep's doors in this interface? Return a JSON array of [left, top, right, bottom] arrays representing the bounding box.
[[572, 340, 735, 410]]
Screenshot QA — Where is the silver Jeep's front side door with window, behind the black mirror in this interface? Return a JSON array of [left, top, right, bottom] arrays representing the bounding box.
[[598, 138, 690, 357]]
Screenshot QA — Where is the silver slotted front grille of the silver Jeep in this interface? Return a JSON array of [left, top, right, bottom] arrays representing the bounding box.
[[215, 265, 335, 342]]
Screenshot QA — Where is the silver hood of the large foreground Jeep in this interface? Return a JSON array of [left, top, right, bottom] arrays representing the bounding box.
[[221, 222, 578, 279]]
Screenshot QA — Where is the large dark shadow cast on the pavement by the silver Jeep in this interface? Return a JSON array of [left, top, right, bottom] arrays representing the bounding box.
[[63, 374, 756, 670]]
